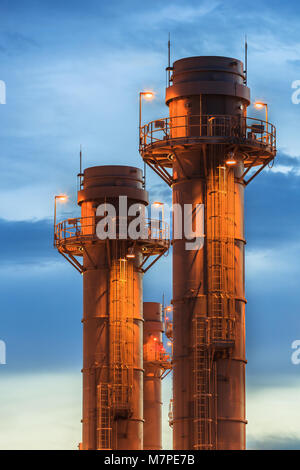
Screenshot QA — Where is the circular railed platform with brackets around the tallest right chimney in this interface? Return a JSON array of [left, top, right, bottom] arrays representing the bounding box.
[[140, 115, 276, 168]]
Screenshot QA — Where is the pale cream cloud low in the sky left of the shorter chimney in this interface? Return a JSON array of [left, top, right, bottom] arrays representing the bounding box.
[[0, 372, 81, 450]]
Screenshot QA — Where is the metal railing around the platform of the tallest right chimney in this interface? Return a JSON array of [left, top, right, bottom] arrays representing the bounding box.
[[140, 115, 276, 151]]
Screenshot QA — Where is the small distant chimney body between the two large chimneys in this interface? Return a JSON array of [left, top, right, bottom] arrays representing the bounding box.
[[143, 302, 163, 450]]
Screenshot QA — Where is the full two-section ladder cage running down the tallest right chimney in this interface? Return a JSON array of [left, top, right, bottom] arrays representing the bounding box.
[[193, 153, 235, 450]]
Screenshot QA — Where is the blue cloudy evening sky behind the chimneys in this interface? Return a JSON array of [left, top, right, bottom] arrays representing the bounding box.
[[0, 0, 300, 449]]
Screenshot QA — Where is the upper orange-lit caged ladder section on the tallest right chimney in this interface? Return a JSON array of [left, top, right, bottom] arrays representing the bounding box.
[[207, 165, 235, 347]]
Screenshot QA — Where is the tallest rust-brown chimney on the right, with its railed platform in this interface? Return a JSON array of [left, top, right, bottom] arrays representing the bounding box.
[[140, 57, 276, 450]]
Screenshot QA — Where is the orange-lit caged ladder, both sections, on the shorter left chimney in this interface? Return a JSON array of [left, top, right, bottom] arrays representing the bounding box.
[[97, 258, 134, 449]]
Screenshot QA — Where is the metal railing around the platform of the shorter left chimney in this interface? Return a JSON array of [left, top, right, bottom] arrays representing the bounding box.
[[54, 216, 170, 245]]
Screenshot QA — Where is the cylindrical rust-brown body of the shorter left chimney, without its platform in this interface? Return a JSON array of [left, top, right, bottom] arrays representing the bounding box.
[[78, 166, 147, 450]]
